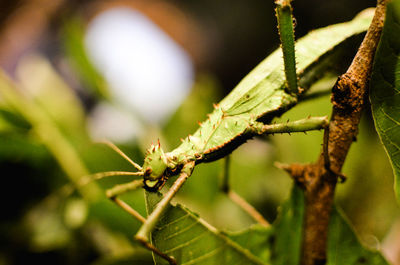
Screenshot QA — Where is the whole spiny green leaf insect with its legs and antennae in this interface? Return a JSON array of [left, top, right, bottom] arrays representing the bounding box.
[[83, 0, 371, 264]]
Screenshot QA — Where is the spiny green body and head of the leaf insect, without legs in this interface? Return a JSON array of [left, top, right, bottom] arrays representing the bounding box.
[[122, 9, 371, 198]]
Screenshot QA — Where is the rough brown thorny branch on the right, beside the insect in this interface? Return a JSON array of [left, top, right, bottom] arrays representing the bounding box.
[[285, 0, 389, 265]]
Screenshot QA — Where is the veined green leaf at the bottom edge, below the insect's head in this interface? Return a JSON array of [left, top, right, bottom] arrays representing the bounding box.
[[146, 192, 268, 265]]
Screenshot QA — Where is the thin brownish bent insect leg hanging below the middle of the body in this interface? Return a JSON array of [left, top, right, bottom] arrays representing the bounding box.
[[221, 156, 270, 226]]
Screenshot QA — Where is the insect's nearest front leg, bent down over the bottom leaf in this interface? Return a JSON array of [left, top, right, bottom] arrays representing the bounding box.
[[135, 162, 194, 264]]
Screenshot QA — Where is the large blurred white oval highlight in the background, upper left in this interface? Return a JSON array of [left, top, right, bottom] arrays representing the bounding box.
[[85, 7, 194, 124]]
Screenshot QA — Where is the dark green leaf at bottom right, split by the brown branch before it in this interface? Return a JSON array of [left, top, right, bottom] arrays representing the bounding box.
[[270, 187, 388, 265]]
